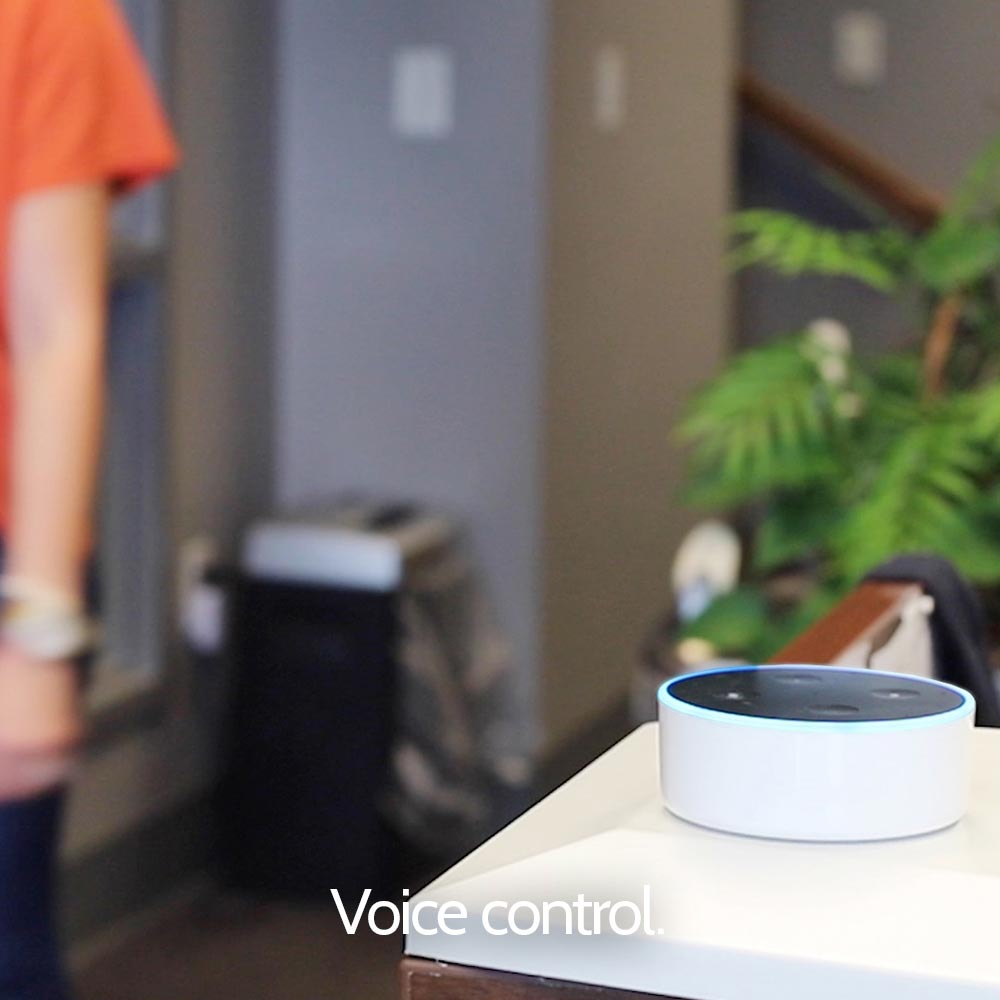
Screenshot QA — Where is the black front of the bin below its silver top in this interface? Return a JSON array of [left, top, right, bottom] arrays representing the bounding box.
[[220, 575, 397, 901]]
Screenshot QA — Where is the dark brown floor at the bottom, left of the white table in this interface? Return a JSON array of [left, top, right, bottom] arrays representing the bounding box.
[[77, 895, 401, 1000]]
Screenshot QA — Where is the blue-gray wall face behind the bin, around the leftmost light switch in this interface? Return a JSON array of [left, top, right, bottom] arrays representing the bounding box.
[[277, 0, 546, 752]]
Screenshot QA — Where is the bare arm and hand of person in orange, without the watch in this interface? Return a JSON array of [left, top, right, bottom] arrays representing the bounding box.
[[0, 185, 108, 784]]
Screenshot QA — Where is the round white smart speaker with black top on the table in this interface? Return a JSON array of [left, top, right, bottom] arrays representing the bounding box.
[[658, 666, 975, 841]]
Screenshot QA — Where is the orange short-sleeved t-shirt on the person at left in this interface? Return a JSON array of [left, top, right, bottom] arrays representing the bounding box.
[[0, 0, 177, 526]]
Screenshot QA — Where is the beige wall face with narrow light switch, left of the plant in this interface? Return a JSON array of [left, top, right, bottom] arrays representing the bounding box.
[[542, 0, 735, 746]]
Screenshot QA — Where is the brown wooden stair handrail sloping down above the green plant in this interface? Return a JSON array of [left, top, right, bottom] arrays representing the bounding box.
[[737, 70, 945, 229]]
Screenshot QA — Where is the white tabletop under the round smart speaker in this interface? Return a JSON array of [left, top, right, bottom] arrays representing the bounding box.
[[405, 723, 1000, 1000]]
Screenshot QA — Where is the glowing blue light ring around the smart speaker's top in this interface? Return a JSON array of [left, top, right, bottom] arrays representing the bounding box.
[[656, 663, 976, 733]]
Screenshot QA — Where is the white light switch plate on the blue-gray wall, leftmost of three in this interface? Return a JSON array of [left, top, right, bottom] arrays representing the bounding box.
[[391, 45, 455, 139]]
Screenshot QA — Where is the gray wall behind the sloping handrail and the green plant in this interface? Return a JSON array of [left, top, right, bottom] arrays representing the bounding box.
[[740, 0, 1000, 346]]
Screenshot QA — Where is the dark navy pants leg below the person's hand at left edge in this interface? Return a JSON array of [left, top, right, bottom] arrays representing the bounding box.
[[0, 789, 70, 1000]]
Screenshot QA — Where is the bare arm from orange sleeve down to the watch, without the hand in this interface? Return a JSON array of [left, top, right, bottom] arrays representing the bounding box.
[[7, 185, 108, 593]]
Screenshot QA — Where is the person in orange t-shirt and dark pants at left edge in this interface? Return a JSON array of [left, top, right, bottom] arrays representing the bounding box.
[[0, 0, 177, 1000]]
